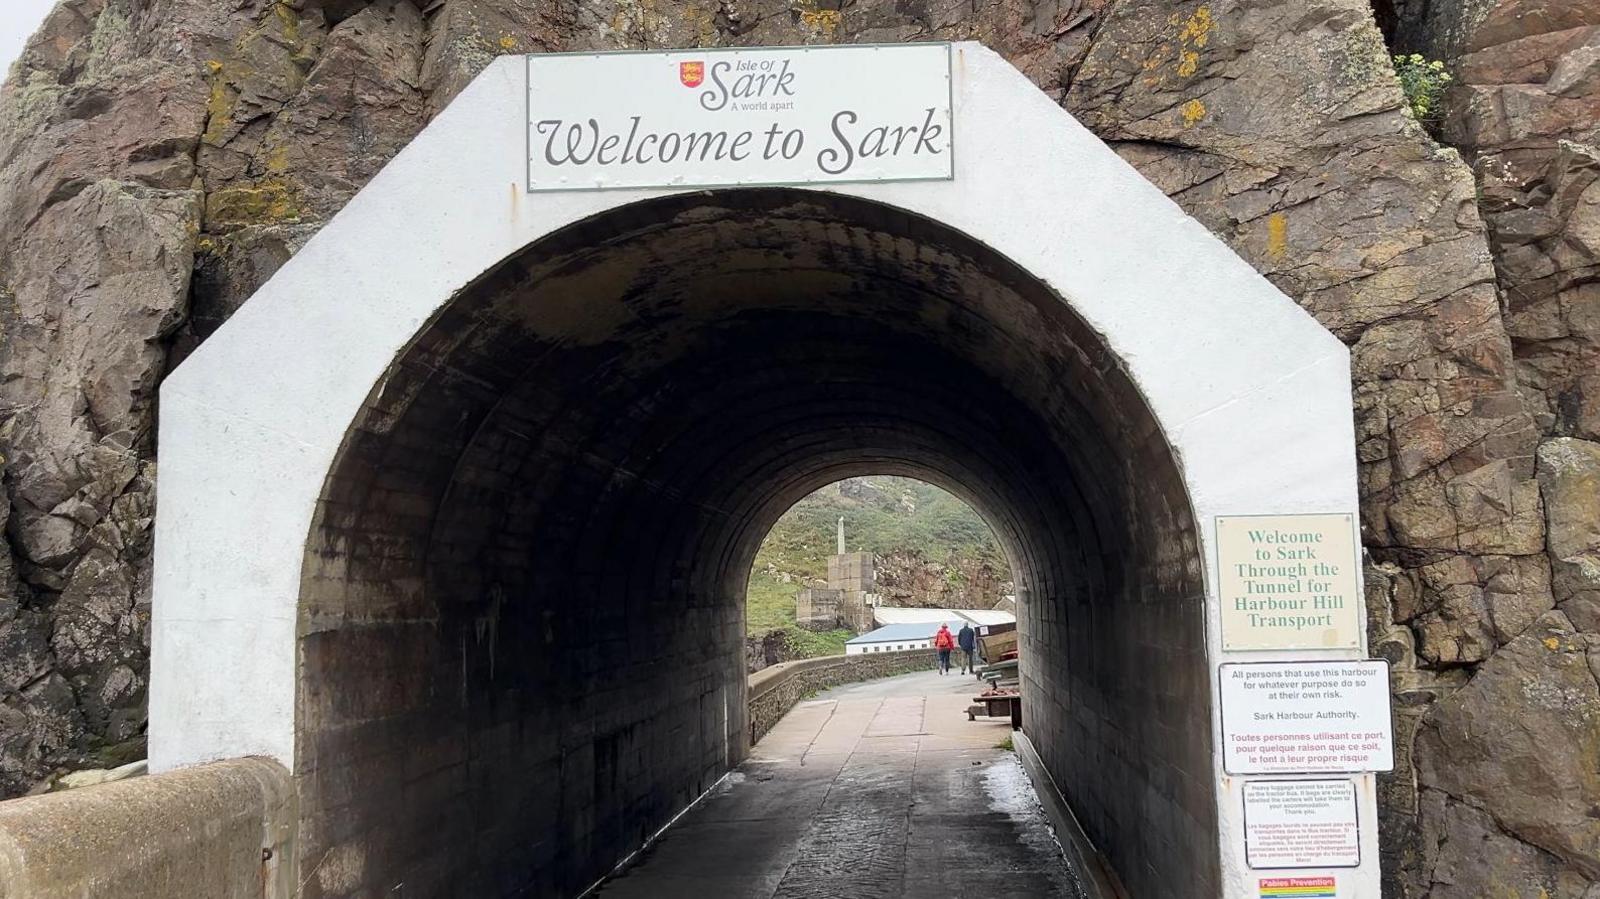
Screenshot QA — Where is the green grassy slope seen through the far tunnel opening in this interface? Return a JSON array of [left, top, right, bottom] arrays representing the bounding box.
[[746, 477, 1005, 657]]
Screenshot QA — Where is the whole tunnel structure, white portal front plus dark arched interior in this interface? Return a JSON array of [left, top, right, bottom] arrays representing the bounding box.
[[152, 46, 1376, 896]]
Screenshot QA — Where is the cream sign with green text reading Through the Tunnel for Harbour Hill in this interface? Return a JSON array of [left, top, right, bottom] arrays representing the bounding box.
[[1216, 513, 1362, 651]]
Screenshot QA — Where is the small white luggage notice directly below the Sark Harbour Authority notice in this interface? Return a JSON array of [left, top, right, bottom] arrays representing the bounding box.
[[1245, 781, 1362, 869]]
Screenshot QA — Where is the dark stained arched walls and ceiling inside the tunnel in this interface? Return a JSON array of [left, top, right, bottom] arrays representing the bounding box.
[[294, 189, 1219, 897]]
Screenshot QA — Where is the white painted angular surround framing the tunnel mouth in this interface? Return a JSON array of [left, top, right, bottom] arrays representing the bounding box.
[[150, 43, 1379, 899]]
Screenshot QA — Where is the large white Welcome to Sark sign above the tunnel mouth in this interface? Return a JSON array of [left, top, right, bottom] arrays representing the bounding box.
[[526, 43, 955, 190]]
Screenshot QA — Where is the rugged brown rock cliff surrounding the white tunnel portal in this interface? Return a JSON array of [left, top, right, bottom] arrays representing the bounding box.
[[0, 0, 1600, 899]]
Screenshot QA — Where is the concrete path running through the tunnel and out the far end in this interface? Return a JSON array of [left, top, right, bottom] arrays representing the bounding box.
[[595, 672, 1078, 899]]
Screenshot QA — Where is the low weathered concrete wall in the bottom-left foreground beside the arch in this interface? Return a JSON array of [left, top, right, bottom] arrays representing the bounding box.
[[0, 758, 294, 899]]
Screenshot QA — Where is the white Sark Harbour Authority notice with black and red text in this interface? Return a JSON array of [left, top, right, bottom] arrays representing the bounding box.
[[1218, 659, 1394, 774]]
